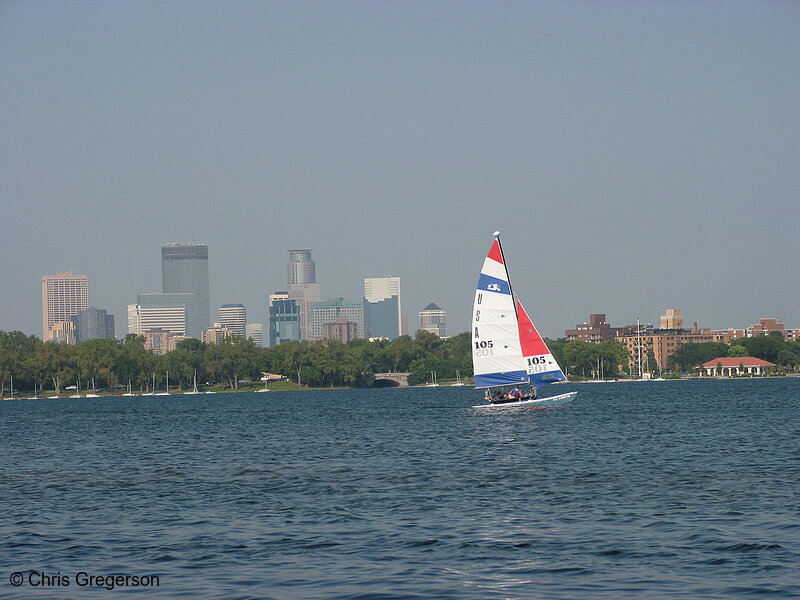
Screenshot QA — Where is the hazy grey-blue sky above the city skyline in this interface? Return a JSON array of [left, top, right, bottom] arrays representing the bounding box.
[[0, 0, 800, 336]]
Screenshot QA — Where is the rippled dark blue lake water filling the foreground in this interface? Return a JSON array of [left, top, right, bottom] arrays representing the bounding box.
[[0, 379, 800, 600]]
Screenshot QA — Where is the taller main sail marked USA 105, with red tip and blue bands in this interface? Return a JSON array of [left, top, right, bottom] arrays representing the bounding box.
[[472, 238, 529, 388]]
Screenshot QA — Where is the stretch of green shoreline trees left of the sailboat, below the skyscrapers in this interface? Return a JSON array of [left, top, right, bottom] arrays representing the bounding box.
[[0, 331, 472, 392]]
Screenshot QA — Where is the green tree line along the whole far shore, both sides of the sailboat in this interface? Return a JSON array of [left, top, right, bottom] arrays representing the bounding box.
[[0, 331, 800, 392]]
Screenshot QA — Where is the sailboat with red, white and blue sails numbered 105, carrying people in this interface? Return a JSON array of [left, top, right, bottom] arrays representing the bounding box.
[[472, 231, 578, 408]]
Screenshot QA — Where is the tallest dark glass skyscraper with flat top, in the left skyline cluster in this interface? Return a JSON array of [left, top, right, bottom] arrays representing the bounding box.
[[161, 242, 211, 339]]
